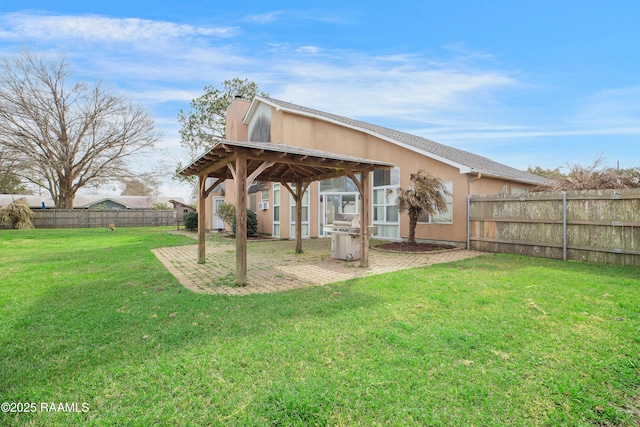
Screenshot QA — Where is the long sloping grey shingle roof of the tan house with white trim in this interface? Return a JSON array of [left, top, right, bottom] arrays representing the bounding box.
[[244, 96, 548, 184]]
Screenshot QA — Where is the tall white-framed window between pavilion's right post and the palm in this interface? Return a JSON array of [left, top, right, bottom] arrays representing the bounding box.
[[372, 168, 400, 239]]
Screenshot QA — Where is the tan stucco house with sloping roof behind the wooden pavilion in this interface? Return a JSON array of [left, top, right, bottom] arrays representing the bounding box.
[[206, 96, 547, 243]]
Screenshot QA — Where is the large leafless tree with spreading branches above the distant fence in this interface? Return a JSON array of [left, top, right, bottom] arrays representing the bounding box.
[[0, 52, 159, 209]]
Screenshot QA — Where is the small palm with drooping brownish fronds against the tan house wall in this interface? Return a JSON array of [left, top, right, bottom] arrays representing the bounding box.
[[397, 169, 449, 245]]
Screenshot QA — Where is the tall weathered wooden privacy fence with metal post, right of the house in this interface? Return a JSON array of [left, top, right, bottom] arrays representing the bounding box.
[[467, 189, 640, 267]]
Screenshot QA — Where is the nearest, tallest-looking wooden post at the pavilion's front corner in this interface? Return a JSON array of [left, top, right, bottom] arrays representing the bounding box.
[[236, 156, 247, 286]]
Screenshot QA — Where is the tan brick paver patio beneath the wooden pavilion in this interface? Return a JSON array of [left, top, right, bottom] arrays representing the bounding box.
[[153, 236, 481, 295]]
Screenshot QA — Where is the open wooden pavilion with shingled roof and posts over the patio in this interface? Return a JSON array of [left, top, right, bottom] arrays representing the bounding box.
[[180, 140, 394, 286]]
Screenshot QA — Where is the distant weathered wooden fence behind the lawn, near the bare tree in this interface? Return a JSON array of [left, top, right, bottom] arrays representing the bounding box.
[[26, 209, 175, 228]]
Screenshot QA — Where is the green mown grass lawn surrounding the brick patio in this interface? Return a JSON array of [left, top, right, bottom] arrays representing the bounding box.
[[0, 228, 640, 426]]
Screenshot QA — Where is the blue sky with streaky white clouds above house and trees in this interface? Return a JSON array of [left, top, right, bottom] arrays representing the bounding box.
[[0, 0, 640, 199]]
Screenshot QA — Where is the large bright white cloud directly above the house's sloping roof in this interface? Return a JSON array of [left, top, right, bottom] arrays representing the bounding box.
[[273, 54, 517, 121]]
